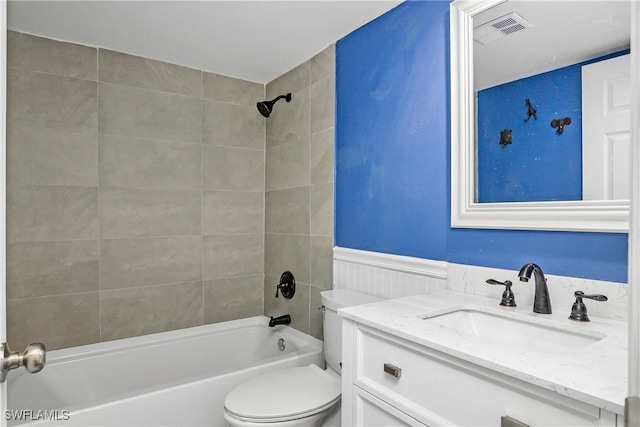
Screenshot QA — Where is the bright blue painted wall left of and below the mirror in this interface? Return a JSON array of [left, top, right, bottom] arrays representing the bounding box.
[[335, 1, 627, 288]]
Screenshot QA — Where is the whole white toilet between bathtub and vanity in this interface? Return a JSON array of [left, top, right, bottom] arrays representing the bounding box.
[[224, 289, 380, 427]]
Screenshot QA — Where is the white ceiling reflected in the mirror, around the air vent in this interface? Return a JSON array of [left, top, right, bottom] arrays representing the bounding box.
[[473, 0, 631, 90]]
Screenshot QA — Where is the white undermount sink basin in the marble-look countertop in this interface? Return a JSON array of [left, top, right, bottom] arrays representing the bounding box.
[[421, 308, 604, 353]]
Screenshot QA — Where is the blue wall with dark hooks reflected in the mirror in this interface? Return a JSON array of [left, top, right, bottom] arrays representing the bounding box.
[[478, 65, 582, 202]]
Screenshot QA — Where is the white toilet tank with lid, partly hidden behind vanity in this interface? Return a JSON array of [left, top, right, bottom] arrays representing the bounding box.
[[320, 289, 381, 373]]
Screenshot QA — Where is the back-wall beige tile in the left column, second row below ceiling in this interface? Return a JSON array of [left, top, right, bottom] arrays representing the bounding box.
[[7, 69, 98, 133]]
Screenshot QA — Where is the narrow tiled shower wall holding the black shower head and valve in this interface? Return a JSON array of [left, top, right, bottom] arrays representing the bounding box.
[[264, 46, 335, 338]]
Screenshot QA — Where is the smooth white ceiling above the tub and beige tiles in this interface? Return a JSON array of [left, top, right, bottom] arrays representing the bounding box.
[[7, 0, 401, 83]]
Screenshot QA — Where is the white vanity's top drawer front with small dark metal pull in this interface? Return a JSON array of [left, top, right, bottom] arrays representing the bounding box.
[[355, 327, 600, 426]]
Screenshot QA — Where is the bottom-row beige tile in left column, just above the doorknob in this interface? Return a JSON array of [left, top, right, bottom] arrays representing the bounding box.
[[7, 292, 100, 351]]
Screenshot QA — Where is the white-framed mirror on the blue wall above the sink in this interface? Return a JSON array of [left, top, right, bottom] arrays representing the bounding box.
[[451, 0, 635, 232]]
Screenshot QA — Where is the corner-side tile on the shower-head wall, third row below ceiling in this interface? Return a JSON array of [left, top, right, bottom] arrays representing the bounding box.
[[265, 137, 311, 191]]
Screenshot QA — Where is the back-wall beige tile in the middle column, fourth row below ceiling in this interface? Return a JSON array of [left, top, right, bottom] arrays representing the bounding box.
[[100, 188, 201, 239]]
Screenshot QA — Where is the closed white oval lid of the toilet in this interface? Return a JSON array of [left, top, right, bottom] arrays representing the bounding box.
[[224, 365, 340, 421]]
